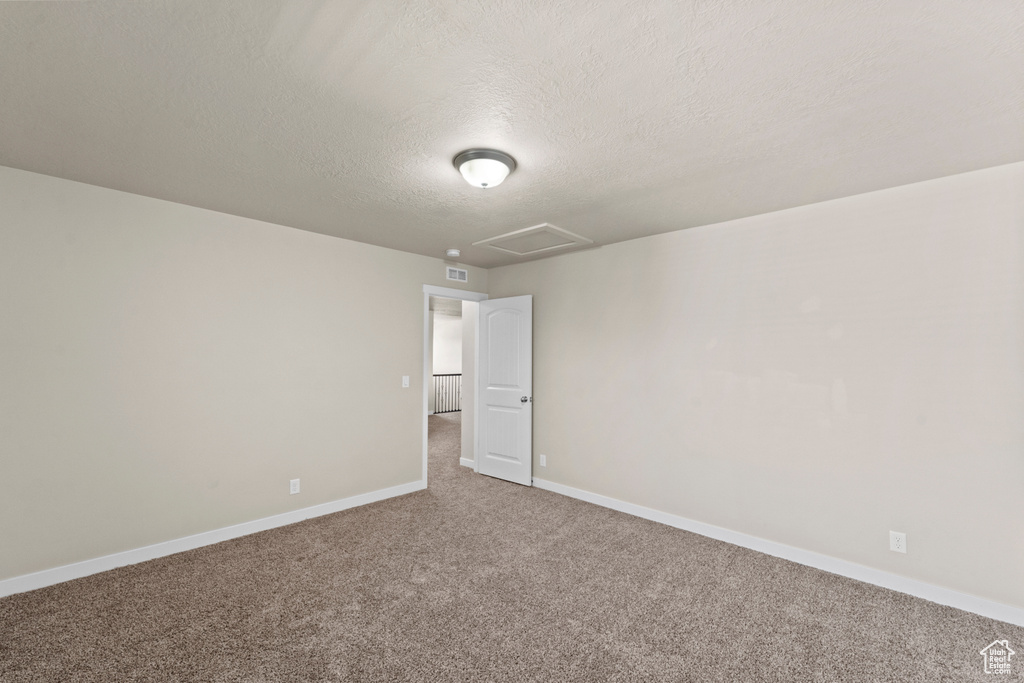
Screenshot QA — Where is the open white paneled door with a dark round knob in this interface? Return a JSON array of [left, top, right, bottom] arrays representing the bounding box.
[[476, 295, 534, 486]]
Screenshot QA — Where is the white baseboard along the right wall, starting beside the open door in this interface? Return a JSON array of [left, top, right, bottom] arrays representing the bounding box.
[[534, 478, 1024, 626]]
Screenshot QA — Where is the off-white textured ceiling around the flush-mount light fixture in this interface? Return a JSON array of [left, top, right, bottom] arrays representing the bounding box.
[[0, 0, 1024, 266]]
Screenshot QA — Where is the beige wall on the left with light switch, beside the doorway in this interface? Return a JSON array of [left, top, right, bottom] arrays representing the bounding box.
[[0, 162, 486, 580]]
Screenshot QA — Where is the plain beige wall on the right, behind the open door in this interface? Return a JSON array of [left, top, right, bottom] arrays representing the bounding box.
[[489, 164, 1024, 606]]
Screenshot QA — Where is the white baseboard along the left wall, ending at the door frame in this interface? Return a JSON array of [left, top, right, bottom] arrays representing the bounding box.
[[0, 480, 427, 598]]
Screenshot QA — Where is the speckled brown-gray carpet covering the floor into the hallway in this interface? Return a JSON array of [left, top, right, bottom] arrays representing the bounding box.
[[0, 414, 1024, 683]]
